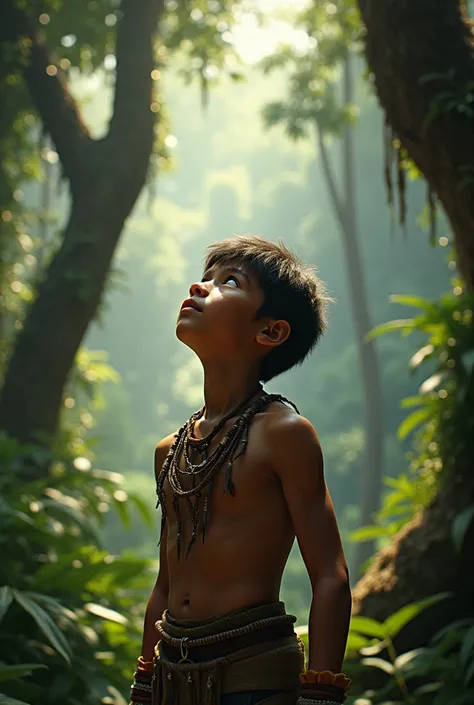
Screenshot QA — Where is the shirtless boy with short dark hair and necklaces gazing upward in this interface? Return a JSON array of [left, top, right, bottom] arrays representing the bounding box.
[[132, 236, 351, 705]]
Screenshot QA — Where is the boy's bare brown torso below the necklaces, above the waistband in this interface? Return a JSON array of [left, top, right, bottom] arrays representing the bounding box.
[[158, 403, 295, 619]]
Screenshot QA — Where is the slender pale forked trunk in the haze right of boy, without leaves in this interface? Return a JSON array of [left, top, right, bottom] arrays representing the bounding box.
[[316, 53, 383, 575]]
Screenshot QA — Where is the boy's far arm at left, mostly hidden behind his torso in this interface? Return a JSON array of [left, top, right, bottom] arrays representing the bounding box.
[[142, 435, 174, 661]]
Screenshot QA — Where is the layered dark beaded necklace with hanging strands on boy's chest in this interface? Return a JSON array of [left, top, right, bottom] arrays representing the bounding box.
[[156, 384, 299, 559]]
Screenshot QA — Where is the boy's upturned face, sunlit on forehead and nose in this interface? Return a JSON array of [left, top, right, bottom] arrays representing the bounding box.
[[176, 263, 264, 360]]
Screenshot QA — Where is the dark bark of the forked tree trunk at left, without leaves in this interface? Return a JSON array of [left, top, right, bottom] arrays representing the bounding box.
[[0, 0, 164, 452]]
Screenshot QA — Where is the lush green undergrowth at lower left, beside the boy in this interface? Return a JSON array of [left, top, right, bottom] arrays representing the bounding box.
[[0, 353, 156, 705]]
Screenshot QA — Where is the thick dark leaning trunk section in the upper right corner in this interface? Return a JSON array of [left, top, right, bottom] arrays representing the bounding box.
[[358, 0, 474, 288]]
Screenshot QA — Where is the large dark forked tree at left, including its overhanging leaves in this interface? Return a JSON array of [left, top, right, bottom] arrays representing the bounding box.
[[0, 0, 241, 460]]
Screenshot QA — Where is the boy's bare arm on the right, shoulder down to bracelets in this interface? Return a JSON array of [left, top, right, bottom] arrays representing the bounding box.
[[269, 415, 351, 673]]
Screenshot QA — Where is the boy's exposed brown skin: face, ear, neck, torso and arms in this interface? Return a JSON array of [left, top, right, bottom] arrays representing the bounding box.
[[142, 258, 351, 672]]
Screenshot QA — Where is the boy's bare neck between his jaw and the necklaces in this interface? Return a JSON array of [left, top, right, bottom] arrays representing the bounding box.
[[204, 362, 259, 425]]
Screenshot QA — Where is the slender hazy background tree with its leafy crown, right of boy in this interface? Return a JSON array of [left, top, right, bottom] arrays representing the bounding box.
[[264, 0, 383, 573]]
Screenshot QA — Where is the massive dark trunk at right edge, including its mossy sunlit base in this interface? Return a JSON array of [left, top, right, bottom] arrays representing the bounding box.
[[354, 0, 474, 647]]
